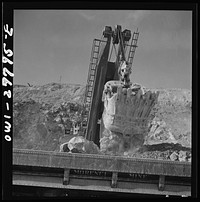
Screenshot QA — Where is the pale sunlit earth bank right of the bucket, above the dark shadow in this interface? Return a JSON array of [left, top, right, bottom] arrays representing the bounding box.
[[146, 89, 192, 148]]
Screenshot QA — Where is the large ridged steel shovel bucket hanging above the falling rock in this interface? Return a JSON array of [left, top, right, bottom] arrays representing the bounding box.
[[103, 81, 158, 135]]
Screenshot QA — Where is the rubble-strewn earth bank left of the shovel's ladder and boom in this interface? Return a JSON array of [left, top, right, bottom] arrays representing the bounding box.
[[13, 83, 85, 151]]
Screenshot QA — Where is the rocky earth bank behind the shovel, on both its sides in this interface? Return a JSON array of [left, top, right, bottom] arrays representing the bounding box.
[[13, 83, 192, 159]]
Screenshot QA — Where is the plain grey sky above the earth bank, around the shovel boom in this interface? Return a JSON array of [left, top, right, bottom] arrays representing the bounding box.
[[14, 10, 192, 89]]
